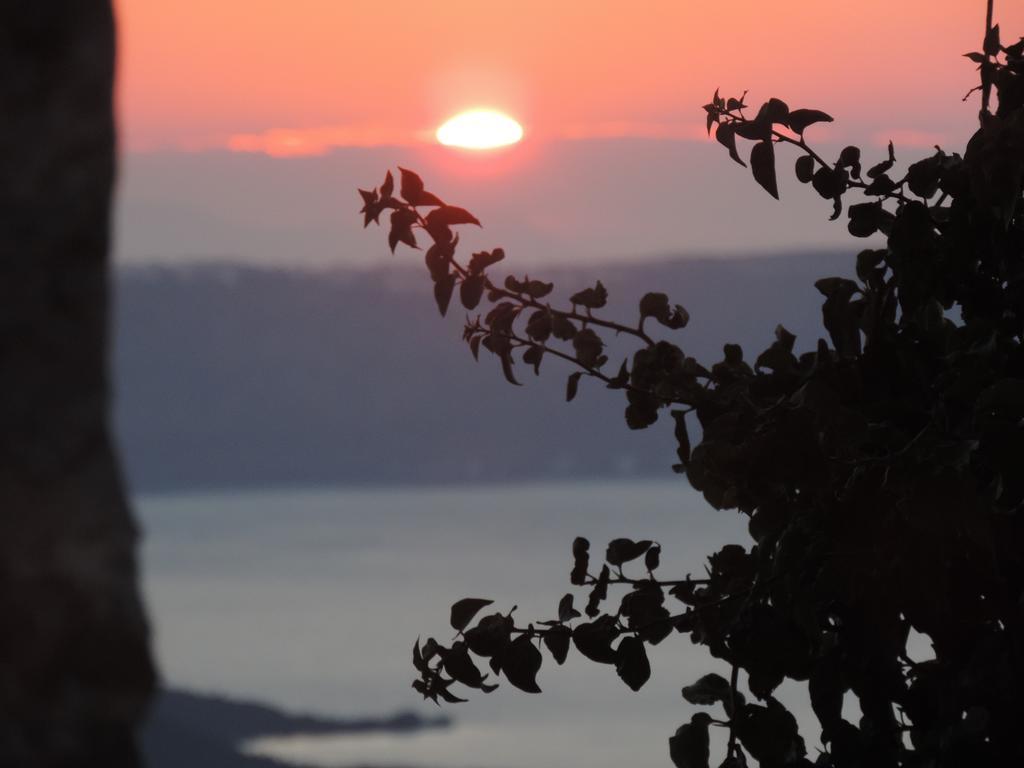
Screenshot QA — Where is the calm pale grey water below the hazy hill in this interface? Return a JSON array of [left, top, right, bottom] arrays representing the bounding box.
[[137, 480, 774, 768]]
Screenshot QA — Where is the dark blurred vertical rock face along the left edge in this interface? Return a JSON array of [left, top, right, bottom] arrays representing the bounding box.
[[0, 0, 155, 767]]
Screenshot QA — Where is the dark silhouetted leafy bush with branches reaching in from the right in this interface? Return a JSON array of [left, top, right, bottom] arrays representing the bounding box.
[[360, 9, 1024, 768]]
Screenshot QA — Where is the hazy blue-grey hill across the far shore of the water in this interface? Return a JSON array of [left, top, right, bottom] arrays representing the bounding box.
[[115, 252, 853, 490]]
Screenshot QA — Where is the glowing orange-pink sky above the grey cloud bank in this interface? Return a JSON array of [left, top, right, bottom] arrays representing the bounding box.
[[115, 0, 1024, 154]]
